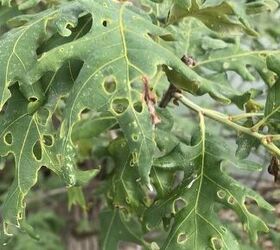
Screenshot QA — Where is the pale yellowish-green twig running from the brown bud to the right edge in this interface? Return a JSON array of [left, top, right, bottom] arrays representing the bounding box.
[[174, 93, 280, 156]]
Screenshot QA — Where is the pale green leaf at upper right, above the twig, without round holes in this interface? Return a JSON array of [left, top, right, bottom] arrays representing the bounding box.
[[168, 18, 278, 86]]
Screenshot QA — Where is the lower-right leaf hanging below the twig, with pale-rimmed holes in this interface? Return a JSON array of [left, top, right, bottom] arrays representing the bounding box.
[[145, 115, 272, 249]]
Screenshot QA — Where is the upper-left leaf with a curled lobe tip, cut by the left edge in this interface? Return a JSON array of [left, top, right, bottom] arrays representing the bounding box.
[[0, 1, 83, 110]]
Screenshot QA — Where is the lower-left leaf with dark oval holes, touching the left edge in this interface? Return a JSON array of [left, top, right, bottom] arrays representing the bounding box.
[[0, 60, 98, 234]]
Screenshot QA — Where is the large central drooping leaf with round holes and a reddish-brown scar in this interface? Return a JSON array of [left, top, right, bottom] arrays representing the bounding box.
[[22, 0, 223, 185]]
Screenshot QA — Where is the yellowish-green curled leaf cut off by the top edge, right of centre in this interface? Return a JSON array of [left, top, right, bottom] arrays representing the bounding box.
[[165, 0, 277, 36]]
